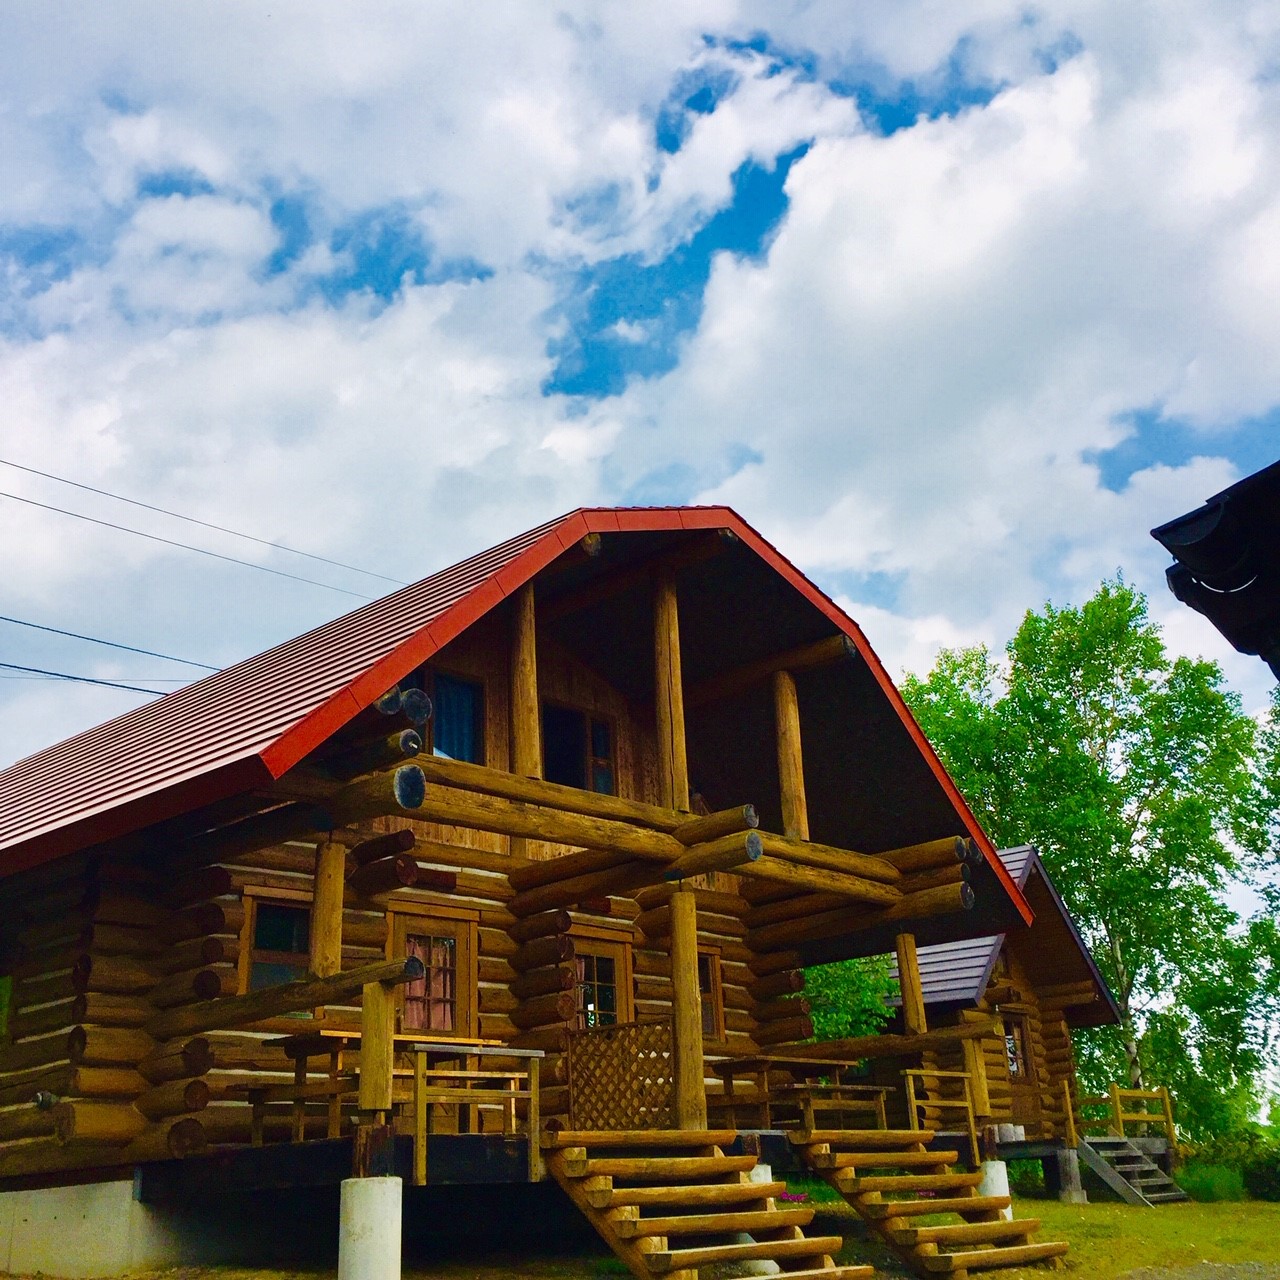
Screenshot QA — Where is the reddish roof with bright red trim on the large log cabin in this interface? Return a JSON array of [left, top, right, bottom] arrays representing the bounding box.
[[0, 507, 1032, 923]]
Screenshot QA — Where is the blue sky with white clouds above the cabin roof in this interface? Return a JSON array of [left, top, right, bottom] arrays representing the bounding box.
[[0, 0, 1280, 773]]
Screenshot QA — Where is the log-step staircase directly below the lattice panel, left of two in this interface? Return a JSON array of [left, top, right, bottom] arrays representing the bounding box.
[[543, 1129, 874, 1280]]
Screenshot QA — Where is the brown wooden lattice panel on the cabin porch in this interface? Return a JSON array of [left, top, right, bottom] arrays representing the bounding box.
[[568, 1019, 675, 1129]]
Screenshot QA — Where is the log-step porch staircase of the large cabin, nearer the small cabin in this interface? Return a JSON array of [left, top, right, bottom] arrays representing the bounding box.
[[791, 1129, 1068, 1280]]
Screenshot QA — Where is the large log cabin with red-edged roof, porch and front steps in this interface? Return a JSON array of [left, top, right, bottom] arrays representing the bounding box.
[[0, 507, 1066, 1280]]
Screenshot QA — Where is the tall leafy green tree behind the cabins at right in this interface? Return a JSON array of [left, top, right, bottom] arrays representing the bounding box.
[[902, 580, 1280, 1123]]
